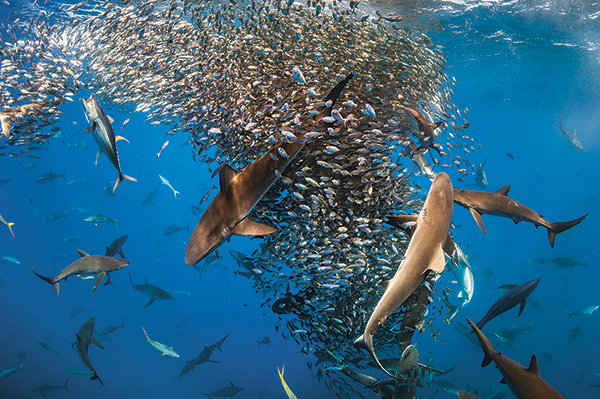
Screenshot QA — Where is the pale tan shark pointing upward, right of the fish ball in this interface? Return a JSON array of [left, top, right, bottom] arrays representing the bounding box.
[[354, 172, 453, 377]]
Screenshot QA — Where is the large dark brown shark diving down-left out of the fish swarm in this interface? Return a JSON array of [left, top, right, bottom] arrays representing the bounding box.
[[185, 73, 354, 266]]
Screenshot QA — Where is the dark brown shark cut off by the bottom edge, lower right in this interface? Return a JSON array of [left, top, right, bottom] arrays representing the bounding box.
[[467, 319, 564, 399]]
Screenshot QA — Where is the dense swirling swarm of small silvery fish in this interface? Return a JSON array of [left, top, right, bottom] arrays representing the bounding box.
[[0, 0, 475, 392]]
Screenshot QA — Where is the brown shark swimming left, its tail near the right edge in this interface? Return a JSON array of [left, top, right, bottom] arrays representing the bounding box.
[[454, 185, 588, 247]]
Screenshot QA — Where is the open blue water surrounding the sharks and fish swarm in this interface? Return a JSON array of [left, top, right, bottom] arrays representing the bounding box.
[[0, 2, 600, 399]]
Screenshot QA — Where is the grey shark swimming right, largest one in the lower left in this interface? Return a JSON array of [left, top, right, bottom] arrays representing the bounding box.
[[31, 249, 131, 295]]
